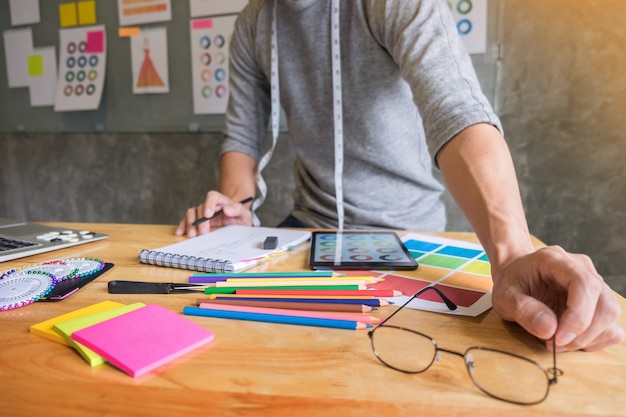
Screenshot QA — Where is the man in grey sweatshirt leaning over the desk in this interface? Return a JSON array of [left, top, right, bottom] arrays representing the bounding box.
[[176, 0, 624, 350]]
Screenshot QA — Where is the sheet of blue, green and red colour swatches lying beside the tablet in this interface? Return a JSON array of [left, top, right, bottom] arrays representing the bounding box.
[[366, 233, 493, 316]]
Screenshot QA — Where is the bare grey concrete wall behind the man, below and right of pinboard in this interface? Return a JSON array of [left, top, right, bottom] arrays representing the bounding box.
[[0, 0, 626, 295]]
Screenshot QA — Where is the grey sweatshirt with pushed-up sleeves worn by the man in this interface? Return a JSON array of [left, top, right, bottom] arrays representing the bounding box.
[[222, 0, 500, 231]]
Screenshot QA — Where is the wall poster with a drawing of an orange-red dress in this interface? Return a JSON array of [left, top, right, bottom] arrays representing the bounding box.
[[130, 27, 170, 94]]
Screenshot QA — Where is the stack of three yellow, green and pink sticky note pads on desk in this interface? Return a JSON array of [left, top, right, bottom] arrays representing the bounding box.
[[31, 301, 214, 377]]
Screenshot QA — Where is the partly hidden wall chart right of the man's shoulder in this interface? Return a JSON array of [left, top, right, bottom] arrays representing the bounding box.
[[446, 0, 487, 54]]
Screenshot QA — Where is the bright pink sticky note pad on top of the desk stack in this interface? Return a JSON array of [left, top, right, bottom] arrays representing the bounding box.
[[72, 304, 215, 377]]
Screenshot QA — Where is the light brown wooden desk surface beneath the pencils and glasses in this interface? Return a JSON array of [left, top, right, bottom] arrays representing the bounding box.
[[0, 224, 626, 417]]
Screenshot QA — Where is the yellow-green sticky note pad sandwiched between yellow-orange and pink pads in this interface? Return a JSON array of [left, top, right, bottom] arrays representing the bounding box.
[[53, 303, 145, 366]]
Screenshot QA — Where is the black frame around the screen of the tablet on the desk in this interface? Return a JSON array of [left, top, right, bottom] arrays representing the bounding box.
[[309, 230, 418, 271]]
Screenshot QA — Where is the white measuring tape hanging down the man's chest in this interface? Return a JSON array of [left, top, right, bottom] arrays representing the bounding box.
[[252, 0, 345, 230]]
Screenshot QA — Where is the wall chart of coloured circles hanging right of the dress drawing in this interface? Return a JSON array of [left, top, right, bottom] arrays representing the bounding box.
[[191, 16, 236, 114]]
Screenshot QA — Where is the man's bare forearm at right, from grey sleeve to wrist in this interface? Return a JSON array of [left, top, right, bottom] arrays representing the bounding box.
[[437, 124, 534, 272]]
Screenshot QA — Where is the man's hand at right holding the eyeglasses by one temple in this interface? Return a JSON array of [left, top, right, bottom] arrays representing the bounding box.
[[493, 246, 624, 351]]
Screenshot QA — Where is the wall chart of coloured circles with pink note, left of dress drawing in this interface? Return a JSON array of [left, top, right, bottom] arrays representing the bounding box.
[[54, 25, 106, 111]]
